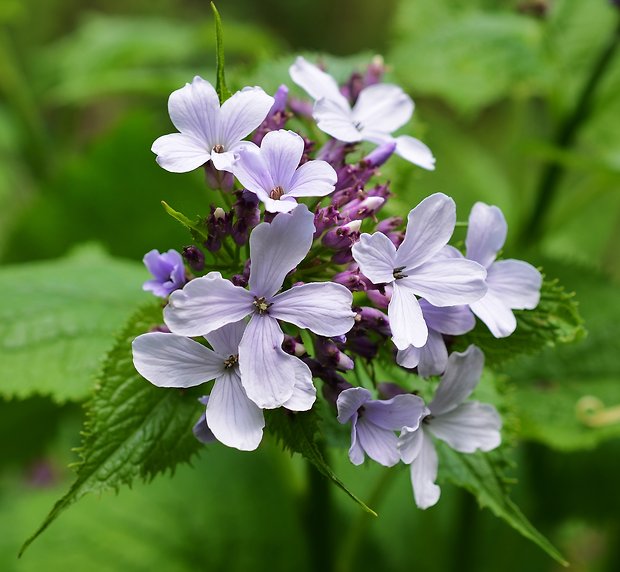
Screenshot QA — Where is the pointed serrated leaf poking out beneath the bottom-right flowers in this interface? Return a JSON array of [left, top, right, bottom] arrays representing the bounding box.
[[437, 442, 568, 566]]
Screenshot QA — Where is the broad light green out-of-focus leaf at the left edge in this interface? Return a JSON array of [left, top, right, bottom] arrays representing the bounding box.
[[0, 246, 148, 402]]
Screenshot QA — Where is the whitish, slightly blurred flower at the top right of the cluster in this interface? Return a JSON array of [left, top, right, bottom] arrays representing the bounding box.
[[289, 56, 435, 170]]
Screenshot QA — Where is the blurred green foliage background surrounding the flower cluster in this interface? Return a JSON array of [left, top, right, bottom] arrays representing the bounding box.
[[0, 0, 620, 572]]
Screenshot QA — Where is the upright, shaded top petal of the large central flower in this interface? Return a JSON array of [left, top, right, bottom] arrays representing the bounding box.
[[250, 205, 314, 298]]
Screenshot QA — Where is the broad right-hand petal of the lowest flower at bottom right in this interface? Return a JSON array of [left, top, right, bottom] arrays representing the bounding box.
[[428, 401, 502, 453]]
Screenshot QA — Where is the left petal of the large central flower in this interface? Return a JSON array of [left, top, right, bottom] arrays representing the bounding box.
[[164, 272, 254, 336]]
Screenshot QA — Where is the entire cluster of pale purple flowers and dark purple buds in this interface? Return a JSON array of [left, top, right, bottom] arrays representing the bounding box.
[[133, 57, 541, 508]]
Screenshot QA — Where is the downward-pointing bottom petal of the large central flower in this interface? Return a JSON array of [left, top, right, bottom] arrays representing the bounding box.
[[239, 314, 295, 409]]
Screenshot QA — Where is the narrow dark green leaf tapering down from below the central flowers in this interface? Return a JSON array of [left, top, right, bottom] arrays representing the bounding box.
[[265, 406, 377, 516]]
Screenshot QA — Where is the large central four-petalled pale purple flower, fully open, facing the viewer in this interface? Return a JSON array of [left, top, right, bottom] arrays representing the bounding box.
[[164, 205, 355, 409]]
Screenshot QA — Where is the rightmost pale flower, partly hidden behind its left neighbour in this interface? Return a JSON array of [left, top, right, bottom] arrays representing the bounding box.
[[465, 203, 542, 338]]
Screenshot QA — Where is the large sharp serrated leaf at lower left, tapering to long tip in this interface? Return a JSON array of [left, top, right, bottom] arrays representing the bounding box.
[[20, 305, 200, 555]]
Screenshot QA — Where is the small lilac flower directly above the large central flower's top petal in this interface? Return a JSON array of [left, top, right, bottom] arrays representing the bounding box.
[[232, 129, 337, 213]]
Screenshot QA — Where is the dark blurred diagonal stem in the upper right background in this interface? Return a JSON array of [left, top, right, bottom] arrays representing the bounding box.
[[522, 13, 620, 244]]
